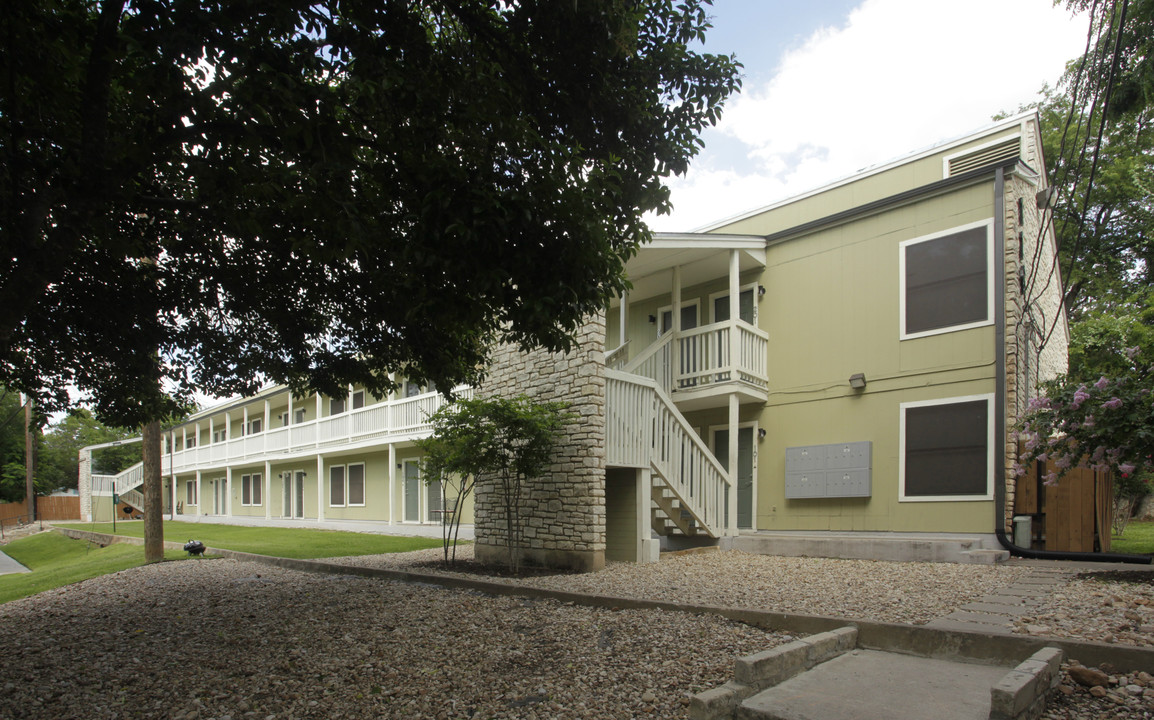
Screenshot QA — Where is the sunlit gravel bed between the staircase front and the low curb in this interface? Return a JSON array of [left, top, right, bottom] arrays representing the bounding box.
[[331, 546, 1031, 624]]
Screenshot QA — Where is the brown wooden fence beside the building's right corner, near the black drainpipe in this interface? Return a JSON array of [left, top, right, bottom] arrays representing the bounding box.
[[1013, 449, 1114, 553]]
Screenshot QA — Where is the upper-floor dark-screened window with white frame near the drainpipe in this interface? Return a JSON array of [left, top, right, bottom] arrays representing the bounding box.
[[900, 220, 994, 338]]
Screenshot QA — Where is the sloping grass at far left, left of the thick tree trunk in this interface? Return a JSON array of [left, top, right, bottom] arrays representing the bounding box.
[[0, 532, 185, 603]]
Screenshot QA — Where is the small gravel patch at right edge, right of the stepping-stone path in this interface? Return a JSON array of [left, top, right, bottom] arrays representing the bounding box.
[[1014, 570, 1154, 650]]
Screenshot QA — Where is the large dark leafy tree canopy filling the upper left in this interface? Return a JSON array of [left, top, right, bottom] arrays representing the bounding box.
[[0, 0, 739, 425]]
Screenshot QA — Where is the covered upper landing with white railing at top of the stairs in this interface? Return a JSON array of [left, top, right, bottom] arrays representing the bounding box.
[[606, 234, 769, 410]]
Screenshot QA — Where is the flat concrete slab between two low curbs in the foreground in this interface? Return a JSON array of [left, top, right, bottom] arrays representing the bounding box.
[[736, 650, 1010, 720]]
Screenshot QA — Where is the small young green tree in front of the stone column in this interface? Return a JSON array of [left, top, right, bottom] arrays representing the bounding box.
[[418, 396, 568, 573]]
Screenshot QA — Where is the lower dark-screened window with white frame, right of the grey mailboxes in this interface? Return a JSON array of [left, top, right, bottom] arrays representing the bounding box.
[[900, 395, 995, 501]]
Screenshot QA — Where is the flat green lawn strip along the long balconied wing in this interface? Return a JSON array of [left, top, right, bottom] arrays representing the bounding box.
[[54, 520, 441, 560]]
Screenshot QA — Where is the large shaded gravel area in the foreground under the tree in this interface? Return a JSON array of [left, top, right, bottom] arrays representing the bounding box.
[[0, 560, 792, 720]]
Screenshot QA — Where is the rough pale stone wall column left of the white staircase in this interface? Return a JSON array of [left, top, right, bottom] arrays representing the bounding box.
[[474, 315, 606, 571]]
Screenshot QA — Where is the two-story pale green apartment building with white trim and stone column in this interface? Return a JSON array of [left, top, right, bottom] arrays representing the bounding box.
[[82, 113, 1066, 569]]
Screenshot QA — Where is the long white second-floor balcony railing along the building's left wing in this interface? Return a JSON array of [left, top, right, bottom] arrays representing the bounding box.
[[162, 388, 473, 474]]
